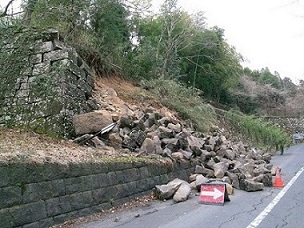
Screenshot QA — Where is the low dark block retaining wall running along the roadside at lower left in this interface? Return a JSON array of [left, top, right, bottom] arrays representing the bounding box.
[[0, 159, 195, 228]]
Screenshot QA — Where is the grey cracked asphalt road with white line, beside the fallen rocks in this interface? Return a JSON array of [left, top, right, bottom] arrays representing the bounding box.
[[77, 144, 304, 228]]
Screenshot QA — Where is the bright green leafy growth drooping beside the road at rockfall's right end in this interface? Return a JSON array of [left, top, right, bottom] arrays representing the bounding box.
[[225, 110, 291, 149]]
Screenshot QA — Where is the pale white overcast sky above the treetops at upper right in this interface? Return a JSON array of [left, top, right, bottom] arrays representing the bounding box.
[[153, 0, 304, 83]]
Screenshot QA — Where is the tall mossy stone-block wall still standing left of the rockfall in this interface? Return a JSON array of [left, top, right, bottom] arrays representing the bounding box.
[[0, 30, 97, 137]]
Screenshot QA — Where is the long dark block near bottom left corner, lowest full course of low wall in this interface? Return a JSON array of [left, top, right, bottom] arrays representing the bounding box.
[[10, 201, 47, 226]]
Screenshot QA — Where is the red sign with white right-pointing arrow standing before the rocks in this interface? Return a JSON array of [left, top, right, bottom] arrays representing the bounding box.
[[199, 183, 226, 205]]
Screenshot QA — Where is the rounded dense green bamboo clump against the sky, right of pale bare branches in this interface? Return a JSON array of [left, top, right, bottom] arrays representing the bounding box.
[[182, 27, 242, 102]]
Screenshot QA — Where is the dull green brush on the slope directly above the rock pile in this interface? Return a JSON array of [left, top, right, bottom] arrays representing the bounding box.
[[142, 79, 215, 132]]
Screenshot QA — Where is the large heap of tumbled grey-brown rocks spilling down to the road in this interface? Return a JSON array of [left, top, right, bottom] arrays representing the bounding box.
[[74, 109, 275, 198]]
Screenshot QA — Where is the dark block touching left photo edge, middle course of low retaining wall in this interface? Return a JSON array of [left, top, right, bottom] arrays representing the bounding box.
[[0, 186, 22, 209]]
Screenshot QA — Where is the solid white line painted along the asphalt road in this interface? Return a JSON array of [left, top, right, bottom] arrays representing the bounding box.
[[247, 166, 304, 228]]
